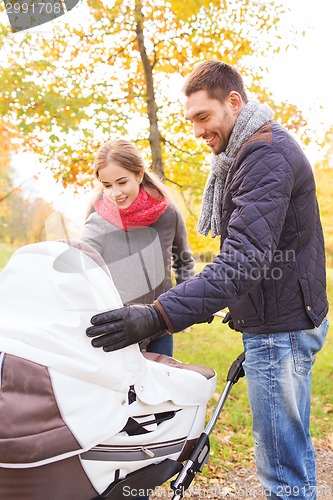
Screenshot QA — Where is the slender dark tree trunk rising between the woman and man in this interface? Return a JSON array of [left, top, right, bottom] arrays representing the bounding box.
[[135, 0, 164, 180]]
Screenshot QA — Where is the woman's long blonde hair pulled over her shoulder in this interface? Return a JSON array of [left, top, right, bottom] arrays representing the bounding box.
[[93, 139, 170, 200]]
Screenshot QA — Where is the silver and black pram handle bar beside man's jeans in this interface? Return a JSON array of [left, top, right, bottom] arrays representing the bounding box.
[[171, 352, 245, 500]]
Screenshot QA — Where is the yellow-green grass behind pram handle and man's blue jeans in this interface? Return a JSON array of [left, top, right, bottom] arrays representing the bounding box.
[[174, 269, 333, 476]]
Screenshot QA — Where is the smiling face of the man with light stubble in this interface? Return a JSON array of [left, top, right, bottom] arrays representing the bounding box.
[[184, 90, 243, 154]]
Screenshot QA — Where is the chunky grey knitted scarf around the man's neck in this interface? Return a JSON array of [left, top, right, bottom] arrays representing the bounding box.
[[197, 100, 273, 238]]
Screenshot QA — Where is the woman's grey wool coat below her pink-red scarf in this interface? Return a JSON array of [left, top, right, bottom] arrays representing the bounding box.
[[80, 203, 194, 304]]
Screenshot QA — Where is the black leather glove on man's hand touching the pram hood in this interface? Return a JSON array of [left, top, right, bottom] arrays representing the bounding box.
[[86, 304, 167, 352]]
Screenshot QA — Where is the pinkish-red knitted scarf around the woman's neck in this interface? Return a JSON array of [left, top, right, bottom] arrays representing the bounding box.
[[95, 187, 169, 231]]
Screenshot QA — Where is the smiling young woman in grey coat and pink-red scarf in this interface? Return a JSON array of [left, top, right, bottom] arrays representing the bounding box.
[[81, 139, 194, 356]]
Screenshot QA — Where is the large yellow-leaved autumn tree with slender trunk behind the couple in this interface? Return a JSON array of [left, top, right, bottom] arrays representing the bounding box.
[[0, 0, 305, 252]]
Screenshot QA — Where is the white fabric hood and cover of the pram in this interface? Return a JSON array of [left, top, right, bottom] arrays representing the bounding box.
[[0, 242, 216, 467]]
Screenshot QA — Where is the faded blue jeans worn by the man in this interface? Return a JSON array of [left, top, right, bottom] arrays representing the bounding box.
[[243, 319, 328, 500]]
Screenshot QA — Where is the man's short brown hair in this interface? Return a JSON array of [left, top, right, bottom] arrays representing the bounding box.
[[183, 61, 248, 103]]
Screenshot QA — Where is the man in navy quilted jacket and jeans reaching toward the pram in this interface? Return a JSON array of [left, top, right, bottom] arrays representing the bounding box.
[[87, 61, 328, 499]]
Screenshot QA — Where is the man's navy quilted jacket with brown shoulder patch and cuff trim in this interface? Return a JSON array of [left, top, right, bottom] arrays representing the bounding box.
[[156, 122, 328, 333]]
